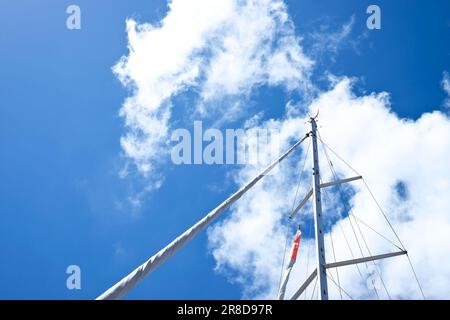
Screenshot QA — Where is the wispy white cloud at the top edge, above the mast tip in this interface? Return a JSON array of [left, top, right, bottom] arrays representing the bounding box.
[[113, 0, 312, 176]]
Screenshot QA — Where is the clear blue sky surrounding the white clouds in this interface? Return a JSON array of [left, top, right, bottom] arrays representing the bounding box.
[[0, 0, 450, 299]]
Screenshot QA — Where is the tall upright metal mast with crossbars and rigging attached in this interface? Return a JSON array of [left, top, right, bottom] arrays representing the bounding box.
[[310, 117, 328, 300]]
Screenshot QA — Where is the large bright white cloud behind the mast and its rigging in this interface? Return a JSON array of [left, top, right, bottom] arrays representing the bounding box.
[[209, 78, 450, 298]]
